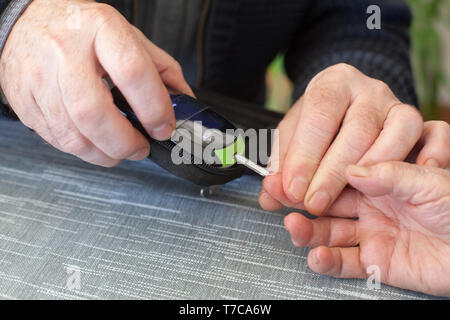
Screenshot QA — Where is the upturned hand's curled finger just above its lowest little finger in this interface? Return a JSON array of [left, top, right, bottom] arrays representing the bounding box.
[[284, 213, 359, 247]]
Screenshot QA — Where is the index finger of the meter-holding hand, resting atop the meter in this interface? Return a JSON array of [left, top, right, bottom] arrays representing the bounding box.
[[95, 17, 175, 140]]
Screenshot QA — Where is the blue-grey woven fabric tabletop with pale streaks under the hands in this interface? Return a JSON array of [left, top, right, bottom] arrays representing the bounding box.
[[0, 120, 442, 299]]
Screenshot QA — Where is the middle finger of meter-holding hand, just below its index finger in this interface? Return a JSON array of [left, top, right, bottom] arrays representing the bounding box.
[[58, 57, 150, 160]]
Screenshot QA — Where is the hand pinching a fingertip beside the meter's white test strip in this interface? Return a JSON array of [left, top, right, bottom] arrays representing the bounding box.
[[260, 64, 442, 215]]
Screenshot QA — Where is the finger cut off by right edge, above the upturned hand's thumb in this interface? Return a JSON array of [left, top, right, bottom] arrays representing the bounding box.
[[416, 121, 450, 168]]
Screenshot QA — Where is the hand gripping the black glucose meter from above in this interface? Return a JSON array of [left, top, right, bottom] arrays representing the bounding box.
[[0, 0, 192, 166]]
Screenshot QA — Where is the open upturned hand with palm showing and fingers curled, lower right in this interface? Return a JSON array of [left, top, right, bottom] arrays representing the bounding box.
[[285, 162, 450, 297]]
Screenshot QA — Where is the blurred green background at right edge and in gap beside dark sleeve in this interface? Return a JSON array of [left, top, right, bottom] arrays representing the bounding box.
[[266, 0, 450, 122]]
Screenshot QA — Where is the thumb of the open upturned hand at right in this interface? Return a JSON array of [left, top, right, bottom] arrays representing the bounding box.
[[345, 161, 450, 204]]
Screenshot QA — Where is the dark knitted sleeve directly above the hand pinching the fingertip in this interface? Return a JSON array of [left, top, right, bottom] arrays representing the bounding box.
[[285, 0, 418, 106]]
